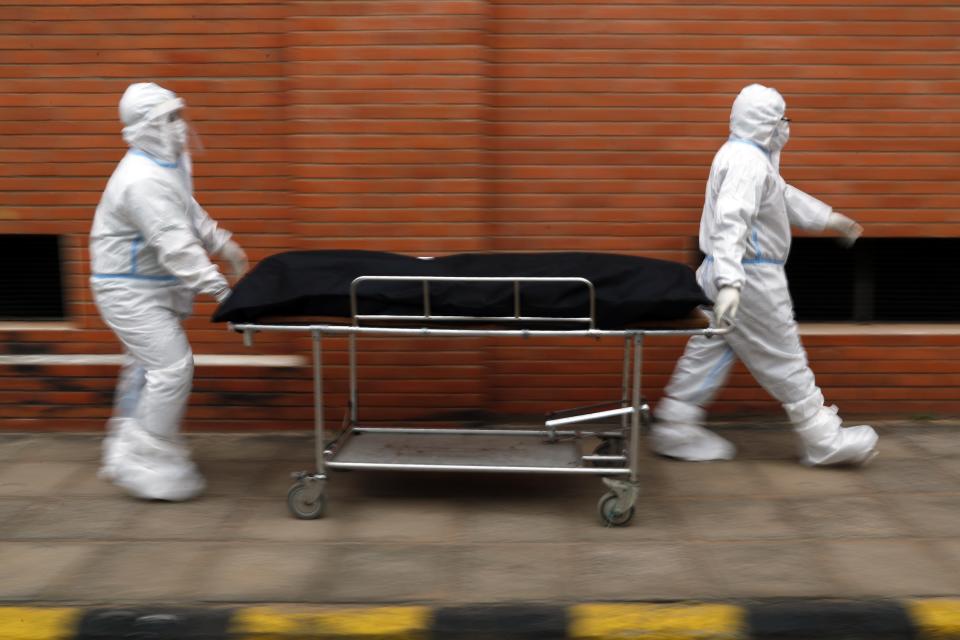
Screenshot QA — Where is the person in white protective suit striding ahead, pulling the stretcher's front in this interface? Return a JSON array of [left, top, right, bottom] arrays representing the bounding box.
[[651, 84, 877, 466]]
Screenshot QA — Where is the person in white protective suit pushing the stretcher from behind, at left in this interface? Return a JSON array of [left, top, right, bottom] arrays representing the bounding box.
[[90, 83, 247, 501]]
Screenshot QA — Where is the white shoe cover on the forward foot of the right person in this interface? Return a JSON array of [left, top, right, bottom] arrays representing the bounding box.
[[796, 406, 878, 467]]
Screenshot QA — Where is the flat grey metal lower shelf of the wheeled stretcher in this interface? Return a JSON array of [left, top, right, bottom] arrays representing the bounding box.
[[327, 427, 630, 475]]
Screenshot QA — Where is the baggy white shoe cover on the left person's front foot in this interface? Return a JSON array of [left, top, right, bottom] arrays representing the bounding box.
[[110, 432, 206, 502]]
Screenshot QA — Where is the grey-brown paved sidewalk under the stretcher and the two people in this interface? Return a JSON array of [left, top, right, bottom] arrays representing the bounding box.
[[0, 422, 960, 636]]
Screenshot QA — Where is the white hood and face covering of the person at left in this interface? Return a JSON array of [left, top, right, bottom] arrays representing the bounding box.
[[120, 82, 186, 164]]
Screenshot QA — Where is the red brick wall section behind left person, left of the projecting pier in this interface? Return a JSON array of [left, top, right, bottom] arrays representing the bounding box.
[[0, 0, 301, 429]]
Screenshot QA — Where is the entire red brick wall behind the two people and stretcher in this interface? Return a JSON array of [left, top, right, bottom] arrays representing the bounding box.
[[0, 0, 960, 428]]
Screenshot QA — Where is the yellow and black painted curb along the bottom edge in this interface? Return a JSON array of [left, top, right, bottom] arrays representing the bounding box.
[[0, 598, 960, 640]]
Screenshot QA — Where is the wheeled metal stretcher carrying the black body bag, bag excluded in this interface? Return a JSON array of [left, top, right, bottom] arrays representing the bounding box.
[[219, 250, 729, 526]]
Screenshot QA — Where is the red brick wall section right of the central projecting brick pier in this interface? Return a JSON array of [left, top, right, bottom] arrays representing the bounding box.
[[490, 0, 960, 414]]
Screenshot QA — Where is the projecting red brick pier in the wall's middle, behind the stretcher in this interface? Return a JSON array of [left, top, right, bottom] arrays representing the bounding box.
[[287, 0, 494, 418]]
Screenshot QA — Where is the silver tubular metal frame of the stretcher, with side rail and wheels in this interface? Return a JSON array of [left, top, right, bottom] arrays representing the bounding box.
[[230, 275, 730, 526]]
